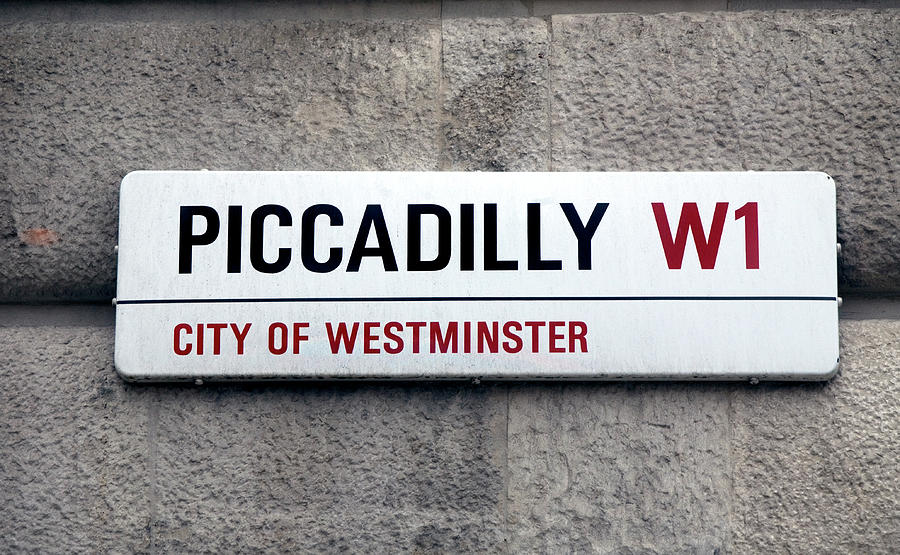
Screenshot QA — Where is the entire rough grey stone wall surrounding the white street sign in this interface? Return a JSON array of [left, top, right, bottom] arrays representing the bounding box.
[[0, 1, 900, 553]]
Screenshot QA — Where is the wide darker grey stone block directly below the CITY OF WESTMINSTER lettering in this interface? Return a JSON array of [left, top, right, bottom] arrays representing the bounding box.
[[154, 384, 506, 553]]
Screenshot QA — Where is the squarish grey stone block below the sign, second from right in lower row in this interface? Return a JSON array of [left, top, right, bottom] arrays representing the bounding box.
[[508, 384, 731, 553]]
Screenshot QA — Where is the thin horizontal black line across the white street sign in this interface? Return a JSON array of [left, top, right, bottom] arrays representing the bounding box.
[[116, 296, 837, 304]]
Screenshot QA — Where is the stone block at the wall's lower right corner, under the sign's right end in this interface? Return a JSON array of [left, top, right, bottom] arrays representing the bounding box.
[[732, 320, 900, 553]]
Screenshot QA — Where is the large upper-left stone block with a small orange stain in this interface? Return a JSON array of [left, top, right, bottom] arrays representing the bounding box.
[[0, 20, 440, 301]]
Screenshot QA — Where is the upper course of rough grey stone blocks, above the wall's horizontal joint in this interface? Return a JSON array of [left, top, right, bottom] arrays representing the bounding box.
[[0, 10, 900, 302]]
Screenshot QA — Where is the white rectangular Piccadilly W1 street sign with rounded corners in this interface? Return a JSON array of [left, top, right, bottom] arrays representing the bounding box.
[[115, 171, 838, 381]]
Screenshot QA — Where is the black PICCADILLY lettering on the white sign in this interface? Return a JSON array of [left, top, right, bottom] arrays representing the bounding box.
[[178, 202, 609, 274]]
